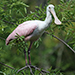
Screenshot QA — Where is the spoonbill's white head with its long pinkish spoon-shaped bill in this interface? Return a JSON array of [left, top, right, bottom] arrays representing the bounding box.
[[47, 4, 61, 25]]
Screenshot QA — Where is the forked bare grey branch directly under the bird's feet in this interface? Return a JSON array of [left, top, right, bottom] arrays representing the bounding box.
[[16, 64, 49, 75]]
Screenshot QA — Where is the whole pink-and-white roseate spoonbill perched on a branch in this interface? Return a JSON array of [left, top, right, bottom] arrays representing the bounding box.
[[6, 4, 61, 64]]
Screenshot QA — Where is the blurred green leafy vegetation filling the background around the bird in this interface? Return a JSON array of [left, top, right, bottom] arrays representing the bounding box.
[[0, 0, 75, 75]]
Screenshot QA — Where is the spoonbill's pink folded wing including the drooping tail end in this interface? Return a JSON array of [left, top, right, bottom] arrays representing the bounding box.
[[6, 22, 37, 45]]
